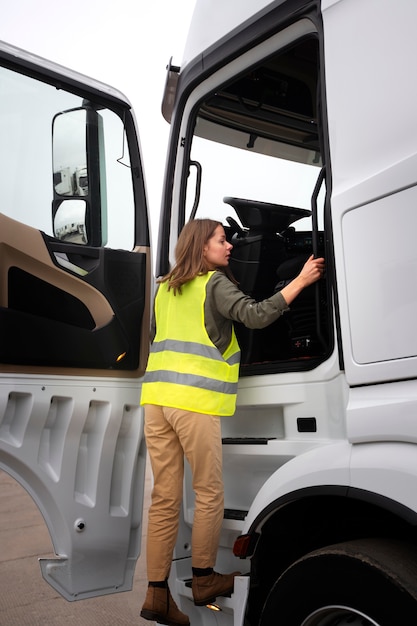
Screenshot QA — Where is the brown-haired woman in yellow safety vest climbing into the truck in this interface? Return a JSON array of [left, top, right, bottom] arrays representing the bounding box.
[[141, 219, 324, 626]]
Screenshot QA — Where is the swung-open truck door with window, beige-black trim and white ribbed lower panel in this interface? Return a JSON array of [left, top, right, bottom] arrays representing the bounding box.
[[0, 44, 151, 600]]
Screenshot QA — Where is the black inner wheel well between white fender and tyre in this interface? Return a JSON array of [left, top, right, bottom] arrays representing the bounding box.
[[247, 486, 417, 624]]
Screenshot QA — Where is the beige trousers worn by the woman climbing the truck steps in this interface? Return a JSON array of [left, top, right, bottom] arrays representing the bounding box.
[[145, 404, 224, 581]]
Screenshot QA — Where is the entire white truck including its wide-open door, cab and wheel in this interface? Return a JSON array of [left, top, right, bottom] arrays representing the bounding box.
[[0, 0, 417, 626]]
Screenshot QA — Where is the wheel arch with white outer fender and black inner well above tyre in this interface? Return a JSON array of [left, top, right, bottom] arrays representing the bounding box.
[[239, 442, 417, 624]]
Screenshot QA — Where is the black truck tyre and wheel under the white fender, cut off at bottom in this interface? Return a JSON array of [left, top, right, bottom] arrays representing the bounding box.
[[260, 539, 417, 626]]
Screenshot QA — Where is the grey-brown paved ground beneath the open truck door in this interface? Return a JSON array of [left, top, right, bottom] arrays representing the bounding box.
[[0, 465, 153, 626]]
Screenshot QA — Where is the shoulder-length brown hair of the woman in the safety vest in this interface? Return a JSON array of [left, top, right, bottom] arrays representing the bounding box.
[[158, 219, 236, 294]]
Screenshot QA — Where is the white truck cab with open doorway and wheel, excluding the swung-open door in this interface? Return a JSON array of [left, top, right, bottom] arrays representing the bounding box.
[[156, 0, 417, 626]]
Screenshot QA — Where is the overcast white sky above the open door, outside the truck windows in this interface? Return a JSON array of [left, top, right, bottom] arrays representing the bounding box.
[[0, 0, 195, 244]]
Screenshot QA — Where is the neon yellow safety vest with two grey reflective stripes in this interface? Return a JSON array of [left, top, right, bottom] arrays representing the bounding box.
[[140, 272, 240, 415]]
